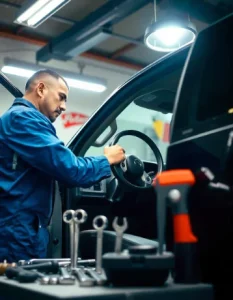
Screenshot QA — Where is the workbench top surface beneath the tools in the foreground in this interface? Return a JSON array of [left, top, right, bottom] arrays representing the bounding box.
[[0, 276, 214, 300]]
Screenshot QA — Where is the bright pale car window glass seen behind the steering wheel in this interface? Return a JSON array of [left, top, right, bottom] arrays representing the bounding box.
[[86, 102, 172, 161]]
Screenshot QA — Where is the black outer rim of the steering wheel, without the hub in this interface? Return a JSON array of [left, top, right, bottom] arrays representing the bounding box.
[[110, 130, 164, 190]]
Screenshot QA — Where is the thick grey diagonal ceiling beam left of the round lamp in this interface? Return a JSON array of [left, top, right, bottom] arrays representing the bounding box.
[[37, 0, 151, 62]]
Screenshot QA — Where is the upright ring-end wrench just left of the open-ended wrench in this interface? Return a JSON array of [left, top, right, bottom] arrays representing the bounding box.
[[93, 216, 108, 274]]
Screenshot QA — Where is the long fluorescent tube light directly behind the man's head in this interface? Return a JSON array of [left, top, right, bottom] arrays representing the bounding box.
[[1, 58, 107, 93]]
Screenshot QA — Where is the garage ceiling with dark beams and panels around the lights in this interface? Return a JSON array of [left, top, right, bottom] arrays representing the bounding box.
[[0, 0, 233, 69]]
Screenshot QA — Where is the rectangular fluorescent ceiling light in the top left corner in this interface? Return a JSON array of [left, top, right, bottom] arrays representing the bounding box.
[[15, 0, 70, 28]]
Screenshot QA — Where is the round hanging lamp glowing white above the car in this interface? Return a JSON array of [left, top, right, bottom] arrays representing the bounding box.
[[144, 1, 197, 52]]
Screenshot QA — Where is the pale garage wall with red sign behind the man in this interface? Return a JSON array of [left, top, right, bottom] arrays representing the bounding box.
[[0, 38, 134, 143]]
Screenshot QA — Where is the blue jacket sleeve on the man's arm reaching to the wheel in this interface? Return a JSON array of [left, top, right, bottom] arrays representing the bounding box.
[[2, 109, 111, 187]]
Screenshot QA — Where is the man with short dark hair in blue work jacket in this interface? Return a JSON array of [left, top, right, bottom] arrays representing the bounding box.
[[0, 69, 125, 262]]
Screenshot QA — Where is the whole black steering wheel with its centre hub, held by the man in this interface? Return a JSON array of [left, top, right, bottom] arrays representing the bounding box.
[[110, 130, 164, 190]]
